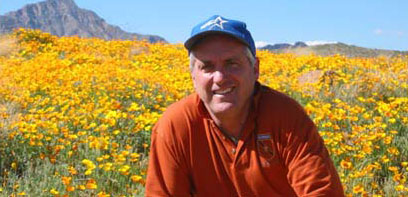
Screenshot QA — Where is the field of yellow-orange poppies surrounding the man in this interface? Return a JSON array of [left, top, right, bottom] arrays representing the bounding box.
[[0, 29, 408, 196]]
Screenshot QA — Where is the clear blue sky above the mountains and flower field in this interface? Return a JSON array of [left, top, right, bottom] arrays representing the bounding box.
[[0, 0, 408, 51]]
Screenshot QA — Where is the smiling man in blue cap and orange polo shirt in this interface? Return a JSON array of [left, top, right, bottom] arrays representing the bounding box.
[[146, 16, 344, 197]]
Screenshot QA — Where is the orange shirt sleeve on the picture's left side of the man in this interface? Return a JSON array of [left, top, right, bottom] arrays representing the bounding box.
[[145, 118, 191, 196]]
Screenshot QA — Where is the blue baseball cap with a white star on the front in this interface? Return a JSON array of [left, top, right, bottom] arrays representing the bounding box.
[[184, 15, 256, 56]]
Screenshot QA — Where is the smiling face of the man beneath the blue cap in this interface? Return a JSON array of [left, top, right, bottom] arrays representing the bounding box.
[[191, 35, 259, 117]]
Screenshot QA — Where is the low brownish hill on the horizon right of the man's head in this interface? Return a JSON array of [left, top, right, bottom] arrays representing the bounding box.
[[259, 42, 408, 57]]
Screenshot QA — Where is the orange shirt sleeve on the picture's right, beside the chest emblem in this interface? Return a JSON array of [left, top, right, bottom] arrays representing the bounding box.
[[283, 106, 344, 197]]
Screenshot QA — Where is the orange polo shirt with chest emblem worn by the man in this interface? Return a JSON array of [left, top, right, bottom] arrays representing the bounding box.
[[145, 84, 344, 197]]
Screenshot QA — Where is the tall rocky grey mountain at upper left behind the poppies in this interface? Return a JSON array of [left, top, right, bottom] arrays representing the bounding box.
[[0, 0, 166, 43]]
